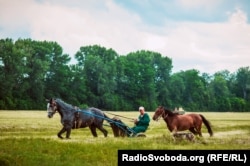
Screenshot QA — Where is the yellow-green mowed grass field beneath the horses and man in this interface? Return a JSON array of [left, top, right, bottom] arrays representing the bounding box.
[[0, 111, 250, 166]]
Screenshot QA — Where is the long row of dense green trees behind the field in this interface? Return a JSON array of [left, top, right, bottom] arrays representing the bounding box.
[[0, 38, 250, 112]]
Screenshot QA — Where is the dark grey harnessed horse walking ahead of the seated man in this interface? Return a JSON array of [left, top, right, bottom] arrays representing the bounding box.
[[47, 98, 112, 139]]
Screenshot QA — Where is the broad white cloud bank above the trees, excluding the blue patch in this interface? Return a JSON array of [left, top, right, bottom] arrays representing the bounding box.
[[0, 0, 250, 74]]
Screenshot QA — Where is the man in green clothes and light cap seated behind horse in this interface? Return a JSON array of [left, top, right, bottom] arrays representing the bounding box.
[[132, 106, 150, 134]]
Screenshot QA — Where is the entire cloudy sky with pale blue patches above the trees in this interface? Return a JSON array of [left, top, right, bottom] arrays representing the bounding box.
[[0, 0, 250, 74]]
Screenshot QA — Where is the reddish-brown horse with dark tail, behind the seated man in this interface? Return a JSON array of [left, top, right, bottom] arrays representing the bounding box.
[[153, 106, 213, 137]]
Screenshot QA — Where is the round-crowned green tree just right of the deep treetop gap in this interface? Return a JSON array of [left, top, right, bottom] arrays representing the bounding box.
[[75, 45, 118, 110]]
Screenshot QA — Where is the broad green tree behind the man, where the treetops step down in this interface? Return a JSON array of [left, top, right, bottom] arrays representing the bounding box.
[[121, 50, 172, 110]]
